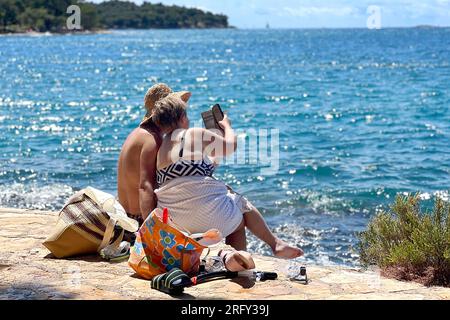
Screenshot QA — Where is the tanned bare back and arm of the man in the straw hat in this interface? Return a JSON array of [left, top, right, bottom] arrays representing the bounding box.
[[117, 127, 161, 219]]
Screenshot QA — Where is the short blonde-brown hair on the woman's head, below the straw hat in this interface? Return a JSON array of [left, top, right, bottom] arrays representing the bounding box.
[[152, 96, 187, 130]]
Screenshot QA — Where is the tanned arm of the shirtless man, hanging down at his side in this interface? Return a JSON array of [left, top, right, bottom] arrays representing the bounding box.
[[139, 139, 158, 220]]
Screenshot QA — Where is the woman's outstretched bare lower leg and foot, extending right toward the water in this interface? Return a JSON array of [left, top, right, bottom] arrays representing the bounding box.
[[244, 206, 303, 259]]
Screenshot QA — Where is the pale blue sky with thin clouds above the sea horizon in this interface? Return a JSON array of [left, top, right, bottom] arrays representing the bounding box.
[[89, 0, 450, 28]]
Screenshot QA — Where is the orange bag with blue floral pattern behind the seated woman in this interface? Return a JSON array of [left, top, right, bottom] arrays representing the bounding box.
[[128, 209, 207, 280]]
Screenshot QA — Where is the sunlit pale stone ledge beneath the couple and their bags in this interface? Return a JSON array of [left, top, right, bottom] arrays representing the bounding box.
[[0, 209, 450, 300]]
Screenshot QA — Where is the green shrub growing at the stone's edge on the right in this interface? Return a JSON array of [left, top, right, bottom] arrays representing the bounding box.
[[359, 195, 450, 286]]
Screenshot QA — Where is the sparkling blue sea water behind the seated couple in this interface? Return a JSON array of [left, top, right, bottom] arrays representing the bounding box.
[[0, 29, 450, 265]]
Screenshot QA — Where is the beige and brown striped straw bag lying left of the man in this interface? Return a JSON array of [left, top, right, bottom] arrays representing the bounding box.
[[43, 187, 139, 258]]
